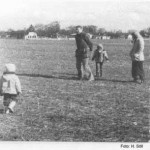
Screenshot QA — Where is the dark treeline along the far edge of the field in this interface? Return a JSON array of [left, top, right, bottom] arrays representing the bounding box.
[[0, 21, 150, 39]]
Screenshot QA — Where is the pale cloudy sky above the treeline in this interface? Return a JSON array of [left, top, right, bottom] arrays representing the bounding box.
[[0, 0, 150, 31]]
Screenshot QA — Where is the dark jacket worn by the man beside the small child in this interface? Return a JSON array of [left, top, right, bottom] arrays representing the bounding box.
[[75, 32, 93, 59]]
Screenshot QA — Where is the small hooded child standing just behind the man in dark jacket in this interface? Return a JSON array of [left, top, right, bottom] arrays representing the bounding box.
[[92, 44, 109, 77]]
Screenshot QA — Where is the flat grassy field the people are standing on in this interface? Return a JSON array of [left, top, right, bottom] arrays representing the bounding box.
[[0, 39, 150, 142]]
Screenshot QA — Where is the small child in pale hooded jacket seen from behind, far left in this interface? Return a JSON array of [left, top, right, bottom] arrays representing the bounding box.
[[0, 64, 21, 114]]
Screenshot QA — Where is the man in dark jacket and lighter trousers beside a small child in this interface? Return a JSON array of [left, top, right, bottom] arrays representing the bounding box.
[[75, 26, 94, 81]]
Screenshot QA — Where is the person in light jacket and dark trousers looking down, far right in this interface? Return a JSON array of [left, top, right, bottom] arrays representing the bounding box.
[[130, 32, 145, 83]]
